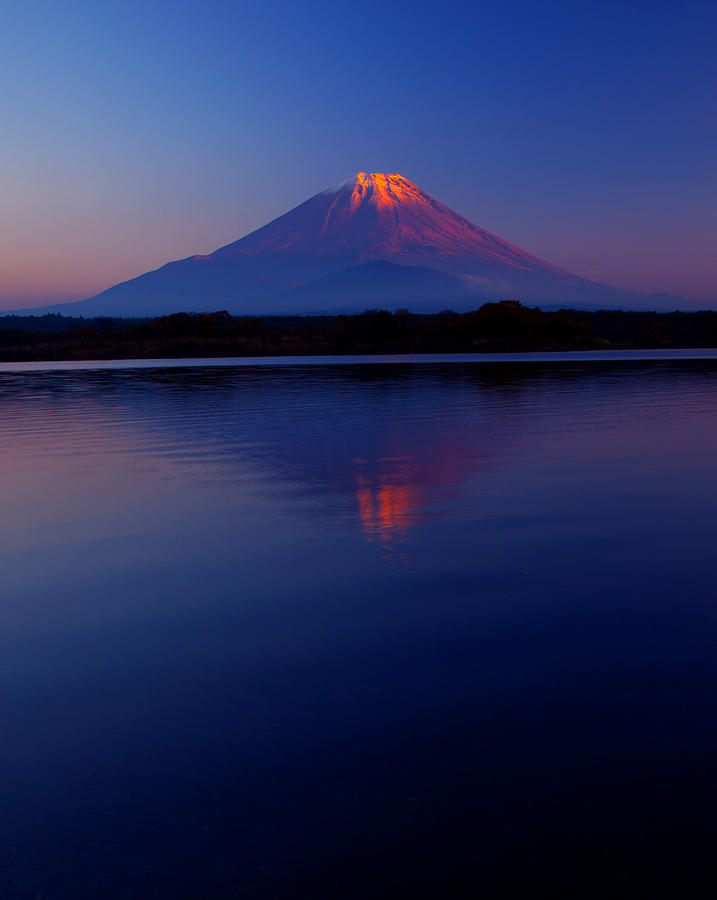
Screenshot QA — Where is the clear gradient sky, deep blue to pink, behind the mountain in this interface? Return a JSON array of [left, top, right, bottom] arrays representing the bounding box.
[[0, 0, 717, 308]]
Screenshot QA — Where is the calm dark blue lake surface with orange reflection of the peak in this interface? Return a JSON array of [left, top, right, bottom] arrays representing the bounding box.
[[0, 357, 717, 900]]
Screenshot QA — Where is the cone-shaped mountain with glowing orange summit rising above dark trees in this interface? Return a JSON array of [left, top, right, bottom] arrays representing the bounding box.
[[15, 172, 692, 316]]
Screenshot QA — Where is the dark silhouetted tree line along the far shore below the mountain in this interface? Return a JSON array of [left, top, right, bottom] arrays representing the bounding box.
[[0, 301, 717, 361]]
